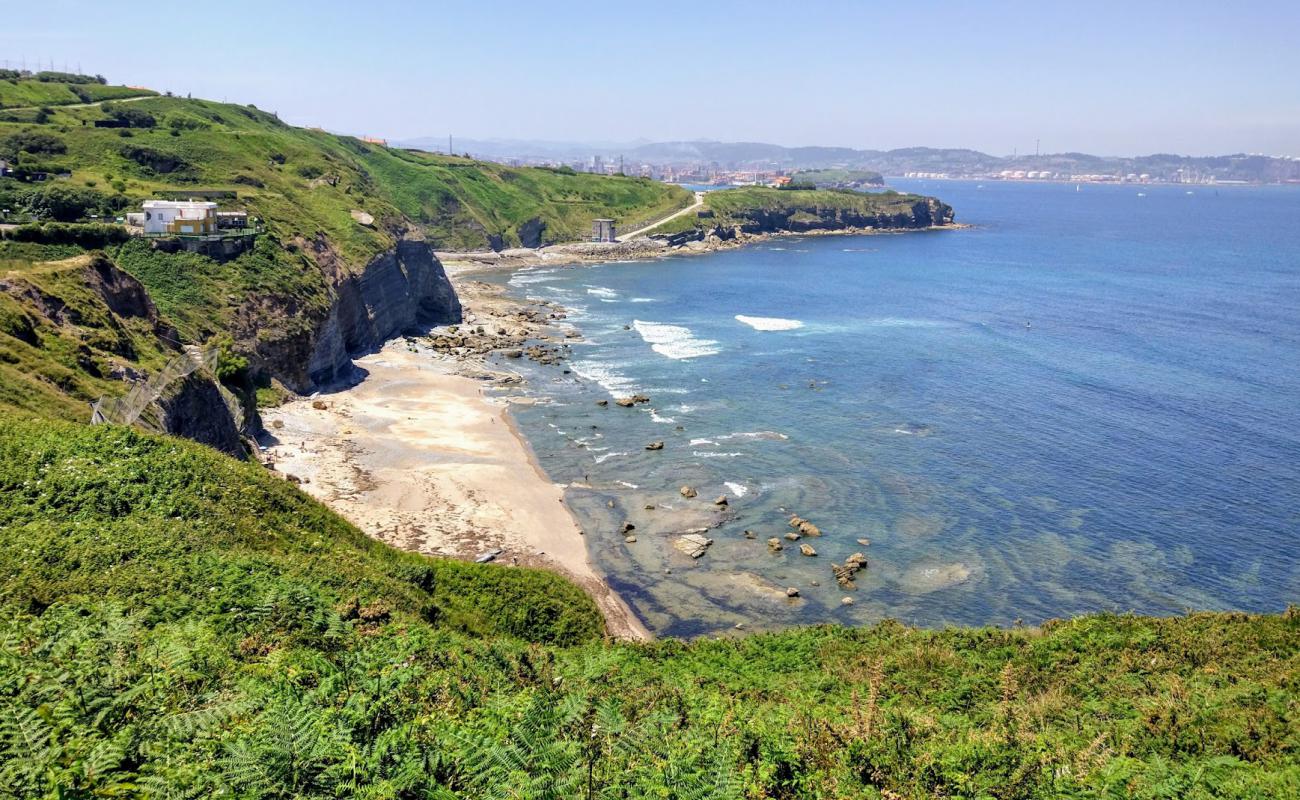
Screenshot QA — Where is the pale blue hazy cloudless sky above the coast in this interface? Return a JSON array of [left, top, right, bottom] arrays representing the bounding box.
[[0, 0, 1300, 156]]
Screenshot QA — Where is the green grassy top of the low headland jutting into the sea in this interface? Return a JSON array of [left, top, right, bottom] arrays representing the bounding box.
[[650, 186, 924, 234]]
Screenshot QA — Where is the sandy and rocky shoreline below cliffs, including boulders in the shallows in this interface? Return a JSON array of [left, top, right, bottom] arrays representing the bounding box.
[[263, 225, 953, 639]]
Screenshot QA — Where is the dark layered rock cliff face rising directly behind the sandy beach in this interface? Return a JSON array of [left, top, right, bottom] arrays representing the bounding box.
[[301, 241, 460, 393]]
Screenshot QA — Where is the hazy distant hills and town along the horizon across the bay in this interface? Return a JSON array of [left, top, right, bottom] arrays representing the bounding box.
[[395, 138, 1300, 183]]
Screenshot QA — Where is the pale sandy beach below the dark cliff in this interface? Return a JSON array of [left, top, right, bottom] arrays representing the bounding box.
[[263, 340, 651, 640]]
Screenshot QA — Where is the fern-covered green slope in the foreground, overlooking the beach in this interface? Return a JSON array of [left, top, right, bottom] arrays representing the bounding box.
[[0, 423, 1300, 797]]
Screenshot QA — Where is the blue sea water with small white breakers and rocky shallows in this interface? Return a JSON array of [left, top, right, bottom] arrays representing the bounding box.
[[488, 182, 1300, 636]]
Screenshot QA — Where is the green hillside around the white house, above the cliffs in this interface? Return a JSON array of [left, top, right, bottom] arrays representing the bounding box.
[[0, 79, 692, 419]]
